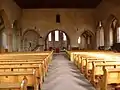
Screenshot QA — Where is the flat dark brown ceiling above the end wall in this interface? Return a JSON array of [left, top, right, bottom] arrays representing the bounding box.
[[14, 0, 102, 9]]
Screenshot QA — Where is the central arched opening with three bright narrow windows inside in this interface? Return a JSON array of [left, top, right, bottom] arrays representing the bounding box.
[[45, 29, 70, 50]]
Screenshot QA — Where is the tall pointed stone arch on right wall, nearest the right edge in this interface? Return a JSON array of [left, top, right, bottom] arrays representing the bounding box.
[[104, 14, 119, 49]]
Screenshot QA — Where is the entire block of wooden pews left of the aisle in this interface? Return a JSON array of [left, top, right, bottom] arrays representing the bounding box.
[[0, 51, 53, 90]]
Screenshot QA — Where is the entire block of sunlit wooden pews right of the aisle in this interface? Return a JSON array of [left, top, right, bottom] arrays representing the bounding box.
[[66, 50, 120, 90]]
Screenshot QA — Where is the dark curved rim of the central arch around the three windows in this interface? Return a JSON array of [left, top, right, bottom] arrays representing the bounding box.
[[45, 29, 70, 49]]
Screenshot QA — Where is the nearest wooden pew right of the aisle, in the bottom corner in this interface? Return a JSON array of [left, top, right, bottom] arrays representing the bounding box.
[[100, 68, 120, 90]]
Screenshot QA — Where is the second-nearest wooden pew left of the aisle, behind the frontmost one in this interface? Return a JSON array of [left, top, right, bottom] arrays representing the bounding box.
[[0, 71, 39, 90]]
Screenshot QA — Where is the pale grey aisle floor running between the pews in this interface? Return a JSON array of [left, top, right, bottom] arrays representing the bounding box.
[[42, 54, 95, 90]]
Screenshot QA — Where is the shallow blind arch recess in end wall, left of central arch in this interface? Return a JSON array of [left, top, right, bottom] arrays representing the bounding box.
[[22, 29, 40, 51]]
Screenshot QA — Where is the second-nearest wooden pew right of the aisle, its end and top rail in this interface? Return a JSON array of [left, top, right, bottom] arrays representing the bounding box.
[[91, 62, 120, 87]]
